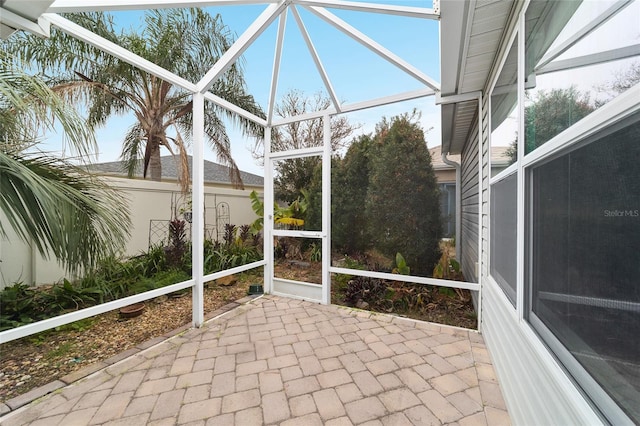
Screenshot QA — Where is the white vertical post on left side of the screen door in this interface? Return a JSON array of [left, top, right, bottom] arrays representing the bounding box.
[[262, 126, 273, 294]]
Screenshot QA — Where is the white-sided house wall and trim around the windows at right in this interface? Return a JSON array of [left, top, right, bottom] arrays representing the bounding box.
[[460, 0, 640, 425]]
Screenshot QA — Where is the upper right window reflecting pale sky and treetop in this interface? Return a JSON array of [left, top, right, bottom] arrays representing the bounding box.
[[524, 0, 640, 154]]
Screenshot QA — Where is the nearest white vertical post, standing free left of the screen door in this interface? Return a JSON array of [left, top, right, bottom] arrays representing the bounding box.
[[191, 93, 204, 327]]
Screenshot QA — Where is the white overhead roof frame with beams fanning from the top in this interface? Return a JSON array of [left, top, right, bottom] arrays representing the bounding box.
[[0, 0, 440, 126]]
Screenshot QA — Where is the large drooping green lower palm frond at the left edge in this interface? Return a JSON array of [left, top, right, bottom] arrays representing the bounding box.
[[0, 152, 129, 273]]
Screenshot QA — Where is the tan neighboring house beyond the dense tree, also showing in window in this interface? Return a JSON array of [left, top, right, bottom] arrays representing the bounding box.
[[429, 145, 510, 238]]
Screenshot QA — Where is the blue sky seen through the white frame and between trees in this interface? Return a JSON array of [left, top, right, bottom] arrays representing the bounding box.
[[45, 0, 440, 174]]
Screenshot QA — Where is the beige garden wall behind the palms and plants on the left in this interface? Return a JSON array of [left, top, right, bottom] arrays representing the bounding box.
[[0, 177, 262, 289]]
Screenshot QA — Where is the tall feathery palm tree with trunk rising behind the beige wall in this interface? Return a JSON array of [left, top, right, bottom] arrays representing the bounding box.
[[10, 9, 264, 188]]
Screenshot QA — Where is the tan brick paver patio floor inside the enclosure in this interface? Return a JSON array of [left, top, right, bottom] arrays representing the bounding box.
[[0, 296, 510, 426]]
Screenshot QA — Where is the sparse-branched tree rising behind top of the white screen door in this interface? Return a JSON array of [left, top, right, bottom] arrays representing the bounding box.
[[254, 90, 357, 202]]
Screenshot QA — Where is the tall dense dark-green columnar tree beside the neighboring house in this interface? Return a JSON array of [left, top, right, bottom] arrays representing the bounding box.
[[365, 110, 442, 275]]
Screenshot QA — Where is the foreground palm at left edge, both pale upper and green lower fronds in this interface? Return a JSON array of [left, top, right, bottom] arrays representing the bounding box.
[[0, 51, 129, 273]]
